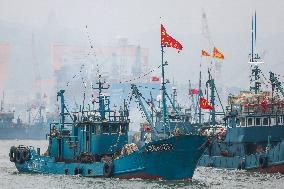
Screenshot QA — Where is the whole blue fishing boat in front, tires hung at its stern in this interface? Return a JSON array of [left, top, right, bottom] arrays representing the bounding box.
[[9, 32, 207, 180]]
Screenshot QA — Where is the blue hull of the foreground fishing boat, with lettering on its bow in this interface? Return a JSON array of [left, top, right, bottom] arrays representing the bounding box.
[[16, 135, 206, 180]]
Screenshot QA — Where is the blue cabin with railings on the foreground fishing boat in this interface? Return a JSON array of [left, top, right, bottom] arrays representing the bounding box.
[[47, 84, 129, 162]]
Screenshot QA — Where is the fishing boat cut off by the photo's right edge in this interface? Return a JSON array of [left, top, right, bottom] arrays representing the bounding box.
[[199, 12, 284, 173]]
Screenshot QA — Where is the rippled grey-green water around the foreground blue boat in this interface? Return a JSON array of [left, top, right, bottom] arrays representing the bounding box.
[[0, 140, 284, 189]]
